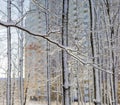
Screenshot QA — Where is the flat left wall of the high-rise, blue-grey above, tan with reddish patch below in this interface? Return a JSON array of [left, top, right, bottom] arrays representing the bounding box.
[[25, 0, 47, 99]]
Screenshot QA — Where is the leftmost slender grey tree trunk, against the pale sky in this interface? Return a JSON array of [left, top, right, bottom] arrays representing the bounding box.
[[6, 0, 11, 105]]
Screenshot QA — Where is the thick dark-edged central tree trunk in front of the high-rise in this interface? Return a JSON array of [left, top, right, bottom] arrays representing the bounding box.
[[62, 0, 70, 105]]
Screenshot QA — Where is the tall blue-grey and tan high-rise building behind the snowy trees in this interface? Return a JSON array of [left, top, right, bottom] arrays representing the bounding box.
[[25, 0, 92, 102]]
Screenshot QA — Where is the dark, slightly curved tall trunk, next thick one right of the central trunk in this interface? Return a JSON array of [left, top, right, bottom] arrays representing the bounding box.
[[89, 0, 101, 105]]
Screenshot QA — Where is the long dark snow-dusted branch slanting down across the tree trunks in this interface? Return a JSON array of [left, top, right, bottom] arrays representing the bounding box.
[[0, 20, 113, 74]]
